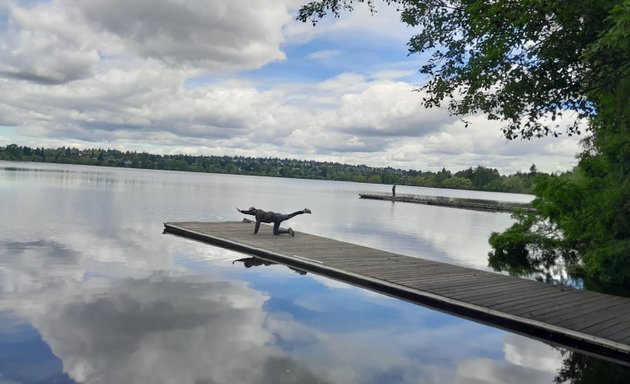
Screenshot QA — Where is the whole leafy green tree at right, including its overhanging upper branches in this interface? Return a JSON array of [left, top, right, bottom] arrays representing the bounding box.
[[298, 0, 630, 291]]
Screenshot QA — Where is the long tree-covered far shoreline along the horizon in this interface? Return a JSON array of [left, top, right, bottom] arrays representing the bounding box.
[[0, 144, 547, 194]]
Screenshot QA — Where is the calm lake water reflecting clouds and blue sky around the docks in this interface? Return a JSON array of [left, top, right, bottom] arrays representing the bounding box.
[[0, 162, 628, 384]]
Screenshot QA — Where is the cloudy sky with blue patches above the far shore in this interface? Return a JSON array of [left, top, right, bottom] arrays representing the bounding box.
[[0, 0, 580, 174]]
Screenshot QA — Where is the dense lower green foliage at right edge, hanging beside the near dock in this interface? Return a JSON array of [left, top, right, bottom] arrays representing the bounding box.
[[490, 101, 630, 294]]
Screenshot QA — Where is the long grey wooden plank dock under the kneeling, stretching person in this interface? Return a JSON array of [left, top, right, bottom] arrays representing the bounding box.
[[164, 222, 630, 366]]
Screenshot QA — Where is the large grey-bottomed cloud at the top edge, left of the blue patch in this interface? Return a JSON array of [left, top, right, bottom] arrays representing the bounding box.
[[64, 0, 291, 70]]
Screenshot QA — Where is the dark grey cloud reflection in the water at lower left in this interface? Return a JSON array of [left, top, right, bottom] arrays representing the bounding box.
[[41, 278, 302, 383]]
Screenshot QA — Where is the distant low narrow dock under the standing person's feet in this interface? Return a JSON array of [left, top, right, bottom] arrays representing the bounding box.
[[359, 193, 535, 212]]
